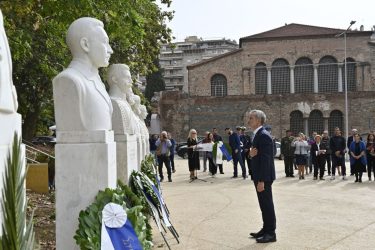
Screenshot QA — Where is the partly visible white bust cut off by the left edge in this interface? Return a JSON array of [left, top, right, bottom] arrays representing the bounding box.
[[0, 10, 18, 114]]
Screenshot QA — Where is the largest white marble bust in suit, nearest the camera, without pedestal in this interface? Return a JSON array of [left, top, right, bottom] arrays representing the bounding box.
[[53, 17, 113, 131]]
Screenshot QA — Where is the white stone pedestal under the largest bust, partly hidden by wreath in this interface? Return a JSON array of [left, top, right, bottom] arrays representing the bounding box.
[[55, 130, 117, 250]]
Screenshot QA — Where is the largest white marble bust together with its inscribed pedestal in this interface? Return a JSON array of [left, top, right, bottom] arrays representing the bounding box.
[[53, 17, 117, 250]]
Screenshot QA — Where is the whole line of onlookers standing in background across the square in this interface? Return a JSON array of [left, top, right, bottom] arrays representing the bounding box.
[[150, 126, 375, 185]]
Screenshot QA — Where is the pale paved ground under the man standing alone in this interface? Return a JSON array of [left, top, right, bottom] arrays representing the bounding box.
[[154, 158, 375, 250]]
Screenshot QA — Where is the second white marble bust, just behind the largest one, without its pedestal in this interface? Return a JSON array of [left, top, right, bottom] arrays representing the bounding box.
[[107, 64, 137, 134]]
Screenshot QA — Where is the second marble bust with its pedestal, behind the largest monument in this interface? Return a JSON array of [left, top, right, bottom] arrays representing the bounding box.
[[108, 64, 140, 183]]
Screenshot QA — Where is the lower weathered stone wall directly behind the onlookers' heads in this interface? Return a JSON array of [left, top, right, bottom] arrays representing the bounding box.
[[159, 91, 375, 142]]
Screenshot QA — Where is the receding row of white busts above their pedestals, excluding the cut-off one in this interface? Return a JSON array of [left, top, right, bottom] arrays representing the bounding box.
[[53, 17, 148, 146]]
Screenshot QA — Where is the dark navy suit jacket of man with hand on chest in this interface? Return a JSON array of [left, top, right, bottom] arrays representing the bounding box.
[[251, 128, 276, 182]]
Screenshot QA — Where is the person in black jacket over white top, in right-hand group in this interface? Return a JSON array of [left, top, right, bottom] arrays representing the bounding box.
[[310, 135, 328, 180]]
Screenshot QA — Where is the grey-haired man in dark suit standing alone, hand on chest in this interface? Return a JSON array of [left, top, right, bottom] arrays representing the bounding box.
[[249, 110, 276, 243]]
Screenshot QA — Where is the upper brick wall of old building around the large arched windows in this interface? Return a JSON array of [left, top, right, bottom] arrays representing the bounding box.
[[188, 36, 375, 96]]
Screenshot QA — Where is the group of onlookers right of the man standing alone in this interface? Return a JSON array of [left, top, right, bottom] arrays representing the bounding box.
[[281, 127, 375, 182]]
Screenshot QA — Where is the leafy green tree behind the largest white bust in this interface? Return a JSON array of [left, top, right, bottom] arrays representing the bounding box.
[[0, 0, 173, 139]]
